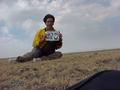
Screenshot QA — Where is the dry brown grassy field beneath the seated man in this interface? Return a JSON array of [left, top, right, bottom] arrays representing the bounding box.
[[0, 49, 120, 90]]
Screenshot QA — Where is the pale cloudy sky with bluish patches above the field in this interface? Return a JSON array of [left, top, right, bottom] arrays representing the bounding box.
[[0, 0, 120, 58]]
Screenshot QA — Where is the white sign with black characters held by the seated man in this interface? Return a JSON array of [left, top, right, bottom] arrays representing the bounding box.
[[45, 31, 60, 41]]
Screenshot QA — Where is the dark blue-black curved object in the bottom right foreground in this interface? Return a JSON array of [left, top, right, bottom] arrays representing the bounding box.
[[66, 70, 120, 90]]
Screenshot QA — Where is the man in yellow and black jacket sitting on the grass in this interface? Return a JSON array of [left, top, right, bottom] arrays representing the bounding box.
[[16, 14, 62, 62]]
